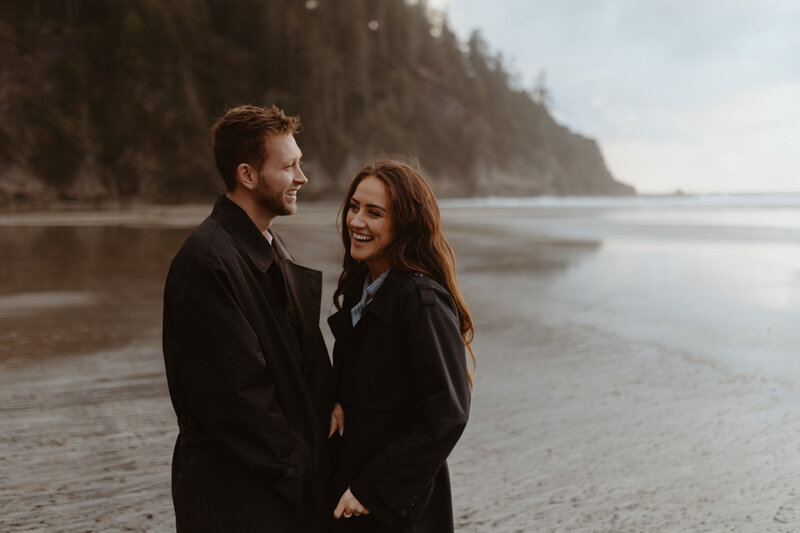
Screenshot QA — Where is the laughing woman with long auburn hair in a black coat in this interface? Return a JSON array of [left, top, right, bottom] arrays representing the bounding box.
[[328, 160, 474, 533]]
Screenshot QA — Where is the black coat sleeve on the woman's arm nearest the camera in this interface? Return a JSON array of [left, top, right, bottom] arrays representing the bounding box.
[[350, 280, 471, 524]]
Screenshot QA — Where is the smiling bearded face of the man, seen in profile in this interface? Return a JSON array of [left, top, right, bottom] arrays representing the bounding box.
[[253, 135, 308, 216]]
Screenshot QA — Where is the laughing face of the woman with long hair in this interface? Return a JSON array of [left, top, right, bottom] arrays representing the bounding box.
[[347, 176, 394, 280]]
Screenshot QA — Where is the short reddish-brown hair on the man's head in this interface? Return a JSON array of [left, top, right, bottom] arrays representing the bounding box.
[[211, 105, 301, 191]]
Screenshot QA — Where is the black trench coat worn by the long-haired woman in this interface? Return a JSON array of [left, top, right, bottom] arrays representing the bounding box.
[[328, 273, 470, 533]]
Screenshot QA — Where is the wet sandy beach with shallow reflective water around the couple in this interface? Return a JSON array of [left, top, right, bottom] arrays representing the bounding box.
[[0, 197, 800, 532]]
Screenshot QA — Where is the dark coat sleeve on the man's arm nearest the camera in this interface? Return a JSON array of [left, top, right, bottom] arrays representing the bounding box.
[[165, 260, 311, 506]]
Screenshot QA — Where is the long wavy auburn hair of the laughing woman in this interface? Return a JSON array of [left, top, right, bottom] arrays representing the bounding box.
[[333, 159, 475, 384]]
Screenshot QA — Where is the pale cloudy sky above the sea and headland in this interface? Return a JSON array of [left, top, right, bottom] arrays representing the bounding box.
[[428, 0, 800, 193]]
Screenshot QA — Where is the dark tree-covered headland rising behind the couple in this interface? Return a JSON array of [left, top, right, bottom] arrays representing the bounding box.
[[0, 0, 634, 206]]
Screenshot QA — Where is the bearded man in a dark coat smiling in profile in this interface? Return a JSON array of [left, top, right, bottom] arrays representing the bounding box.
[[164, 106, 333, 533]]
